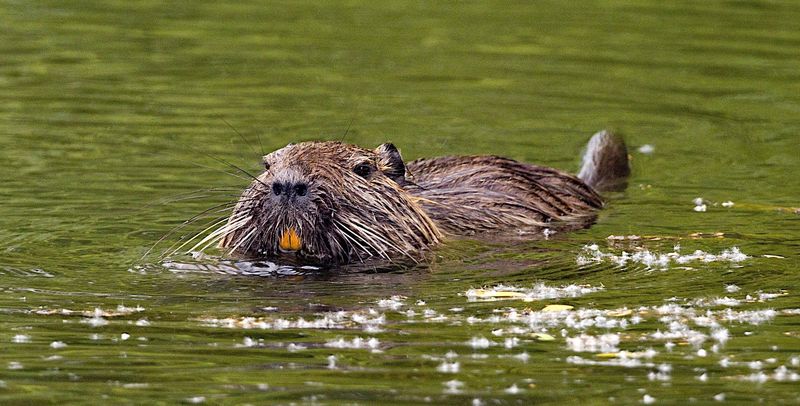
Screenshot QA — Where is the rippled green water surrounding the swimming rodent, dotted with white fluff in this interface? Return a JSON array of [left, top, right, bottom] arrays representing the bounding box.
[[0, 0, 800, 404]]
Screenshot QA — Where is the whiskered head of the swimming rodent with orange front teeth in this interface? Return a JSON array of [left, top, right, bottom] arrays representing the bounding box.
[[218, 142, 441, 263]]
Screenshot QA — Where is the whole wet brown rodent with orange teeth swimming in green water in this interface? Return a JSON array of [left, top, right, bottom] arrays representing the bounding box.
[[213, 131, 630, 264]]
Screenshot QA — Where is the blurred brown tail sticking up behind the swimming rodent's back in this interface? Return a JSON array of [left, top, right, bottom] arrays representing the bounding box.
[[578, 130, 631, 192]]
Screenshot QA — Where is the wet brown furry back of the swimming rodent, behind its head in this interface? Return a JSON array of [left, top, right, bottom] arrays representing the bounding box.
[[408, 156, 603, 235]]
